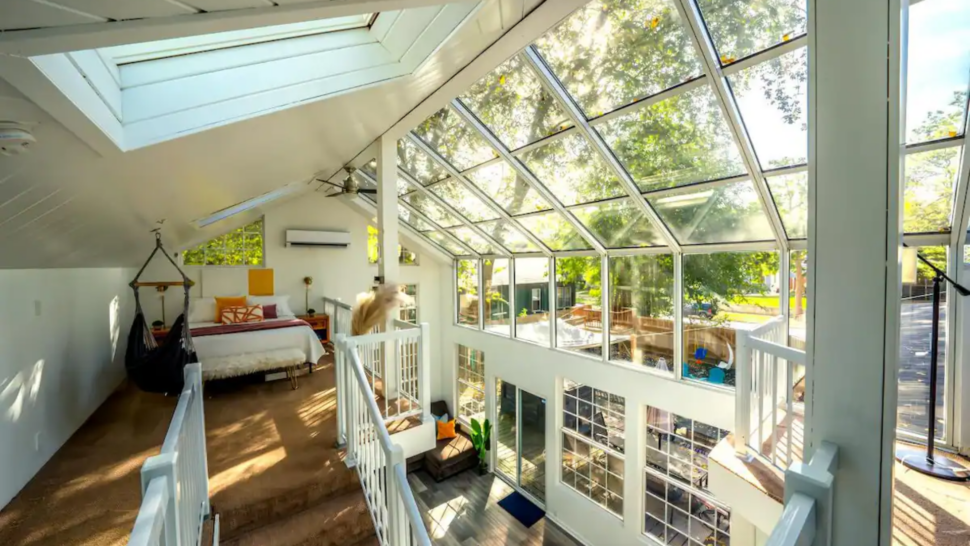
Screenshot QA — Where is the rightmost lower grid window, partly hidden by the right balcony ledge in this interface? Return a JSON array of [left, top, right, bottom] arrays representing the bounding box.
[[643, 406, 731, 546]]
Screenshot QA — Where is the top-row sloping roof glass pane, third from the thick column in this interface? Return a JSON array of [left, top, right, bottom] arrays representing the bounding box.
[[460, 57, 572, 150]]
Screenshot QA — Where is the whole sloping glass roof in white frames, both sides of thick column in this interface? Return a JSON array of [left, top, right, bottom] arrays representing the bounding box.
[[365, 0, 970, 256]]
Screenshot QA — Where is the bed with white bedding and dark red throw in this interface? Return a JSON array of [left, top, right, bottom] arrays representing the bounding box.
[[189, 296, 326, 380]]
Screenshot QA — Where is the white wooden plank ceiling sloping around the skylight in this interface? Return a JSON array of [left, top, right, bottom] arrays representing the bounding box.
[[0, 0, 544, 268]]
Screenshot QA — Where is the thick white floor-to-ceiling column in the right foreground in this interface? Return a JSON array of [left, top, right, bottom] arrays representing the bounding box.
[[806, 0, 905, 545]]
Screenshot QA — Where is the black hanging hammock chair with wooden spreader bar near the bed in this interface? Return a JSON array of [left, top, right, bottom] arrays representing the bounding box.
[[125, 230, 198, 394]]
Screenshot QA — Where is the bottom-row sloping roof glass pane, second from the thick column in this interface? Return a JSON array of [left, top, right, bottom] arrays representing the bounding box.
[[647, 180, 774, 245]]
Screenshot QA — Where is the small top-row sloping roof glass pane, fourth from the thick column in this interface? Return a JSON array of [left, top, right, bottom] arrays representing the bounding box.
[[413, 107, 496, 171]]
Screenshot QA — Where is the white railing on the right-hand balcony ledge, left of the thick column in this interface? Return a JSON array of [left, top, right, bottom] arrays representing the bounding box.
[[734, 317, 805, 470]]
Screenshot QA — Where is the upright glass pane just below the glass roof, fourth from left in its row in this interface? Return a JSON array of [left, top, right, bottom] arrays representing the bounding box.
[[556, 256, 603, 355]]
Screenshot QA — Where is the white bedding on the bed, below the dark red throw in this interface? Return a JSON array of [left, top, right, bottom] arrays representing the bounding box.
[[189, 317, 326, 368]]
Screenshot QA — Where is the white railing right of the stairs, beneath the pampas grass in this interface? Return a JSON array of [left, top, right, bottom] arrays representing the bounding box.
[[336, 324, 431, 546]]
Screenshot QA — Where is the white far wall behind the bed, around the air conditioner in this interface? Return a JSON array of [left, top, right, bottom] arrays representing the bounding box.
[[141, 192, 447, 396]]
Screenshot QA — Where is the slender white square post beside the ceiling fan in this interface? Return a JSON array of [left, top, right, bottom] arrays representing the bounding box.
[[377, 135, 400, 402]]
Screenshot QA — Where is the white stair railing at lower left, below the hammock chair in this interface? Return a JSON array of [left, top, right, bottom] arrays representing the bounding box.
[[128, 364, 218, 546]]
